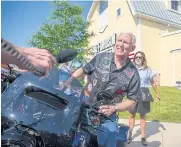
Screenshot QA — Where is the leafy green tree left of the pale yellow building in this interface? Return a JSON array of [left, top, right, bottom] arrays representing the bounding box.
[[28, 1, 93, 60]]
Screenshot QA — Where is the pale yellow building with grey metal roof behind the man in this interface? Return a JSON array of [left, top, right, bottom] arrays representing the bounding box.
[[87, 0, 181, 86]]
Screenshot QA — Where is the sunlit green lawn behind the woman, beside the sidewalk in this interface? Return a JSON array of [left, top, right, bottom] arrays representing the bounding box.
[[119, 87, 181, 123]]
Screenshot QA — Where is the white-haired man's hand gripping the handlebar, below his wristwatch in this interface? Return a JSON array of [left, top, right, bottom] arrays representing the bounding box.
[[99, 105, 116, 116]]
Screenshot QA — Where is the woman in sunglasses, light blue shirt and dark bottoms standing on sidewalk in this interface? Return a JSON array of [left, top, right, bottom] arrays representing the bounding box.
[[128, 51, 160, 146]]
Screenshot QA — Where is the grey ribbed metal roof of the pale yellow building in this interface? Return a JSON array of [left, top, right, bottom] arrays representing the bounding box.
[[130, 0, 181, 26]]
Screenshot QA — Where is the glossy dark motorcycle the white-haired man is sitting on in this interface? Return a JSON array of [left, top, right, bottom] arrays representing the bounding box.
[[1, 50, 129, 147]]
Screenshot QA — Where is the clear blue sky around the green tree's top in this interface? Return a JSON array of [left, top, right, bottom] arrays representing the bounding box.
[[1, 0, 92, 47]]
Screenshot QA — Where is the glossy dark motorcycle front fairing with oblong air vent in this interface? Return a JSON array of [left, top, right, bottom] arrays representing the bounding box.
[[1, 69, 84, 133]]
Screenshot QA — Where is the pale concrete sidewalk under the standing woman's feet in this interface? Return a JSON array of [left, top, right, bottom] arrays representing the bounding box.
[[119, 119, 181, 147]]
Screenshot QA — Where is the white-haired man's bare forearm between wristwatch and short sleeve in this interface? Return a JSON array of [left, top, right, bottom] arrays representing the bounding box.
[[117, 100, 136, 111]]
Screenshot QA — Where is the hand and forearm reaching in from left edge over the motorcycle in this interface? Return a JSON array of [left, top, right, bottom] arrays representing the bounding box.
[[1, 38, 56, 76]]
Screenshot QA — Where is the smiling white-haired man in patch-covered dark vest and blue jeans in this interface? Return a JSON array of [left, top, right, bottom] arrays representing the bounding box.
[[65, 33, 140, 147]]
